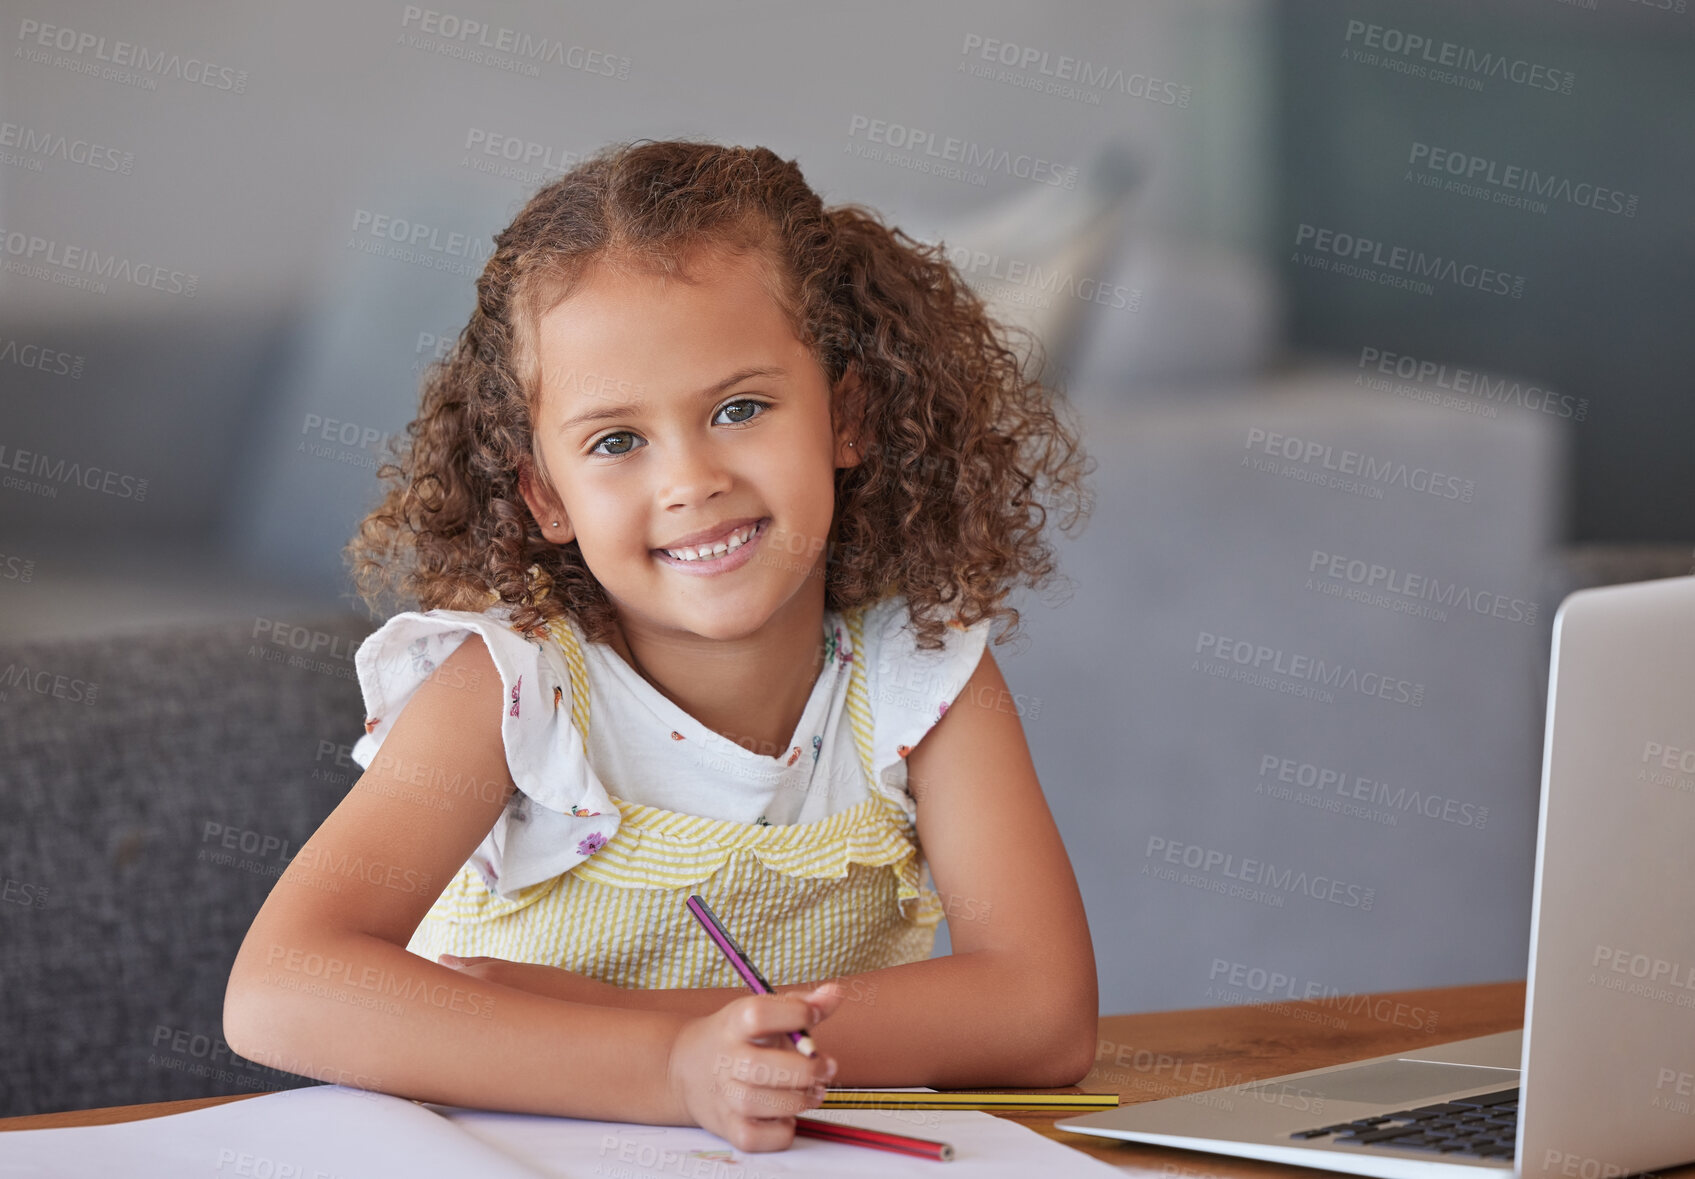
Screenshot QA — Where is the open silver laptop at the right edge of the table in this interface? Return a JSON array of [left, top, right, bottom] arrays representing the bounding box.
[[1056, 576, 1695, 1179]]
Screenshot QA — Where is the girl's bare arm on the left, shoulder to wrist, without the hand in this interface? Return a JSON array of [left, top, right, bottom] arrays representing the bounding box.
[[224, 635, 690, 1125]]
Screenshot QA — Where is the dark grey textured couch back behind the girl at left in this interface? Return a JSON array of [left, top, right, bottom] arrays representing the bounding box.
[[0, 615, 373, 1116]]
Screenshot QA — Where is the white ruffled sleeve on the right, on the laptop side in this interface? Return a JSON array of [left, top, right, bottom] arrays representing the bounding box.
[[863, 596, 993, 818]]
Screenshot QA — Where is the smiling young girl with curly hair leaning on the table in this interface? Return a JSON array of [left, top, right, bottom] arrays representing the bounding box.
[[224, 141, 1097, 1150]]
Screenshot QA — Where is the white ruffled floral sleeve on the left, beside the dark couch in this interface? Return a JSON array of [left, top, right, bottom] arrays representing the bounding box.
[[353, 606, 622, 899]]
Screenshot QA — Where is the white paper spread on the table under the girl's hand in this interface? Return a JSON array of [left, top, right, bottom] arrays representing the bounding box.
[[0, 1084, 1120, 1179]]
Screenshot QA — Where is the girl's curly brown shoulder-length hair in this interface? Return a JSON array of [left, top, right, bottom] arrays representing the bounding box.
[[346, 141, 1093, 649]]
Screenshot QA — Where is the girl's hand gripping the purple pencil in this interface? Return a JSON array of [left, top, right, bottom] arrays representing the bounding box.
[[666, 983, 842, 1152]]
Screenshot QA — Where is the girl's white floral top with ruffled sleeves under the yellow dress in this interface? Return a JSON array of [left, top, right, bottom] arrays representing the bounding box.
[[353, 596, 990, 898]]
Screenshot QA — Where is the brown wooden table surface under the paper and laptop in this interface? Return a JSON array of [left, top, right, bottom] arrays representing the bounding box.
[[0, 983, 1695, 1179]]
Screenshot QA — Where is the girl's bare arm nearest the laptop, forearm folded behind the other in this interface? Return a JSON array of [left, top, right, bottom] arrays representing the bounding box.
[[447, 650, 1098, 1089]]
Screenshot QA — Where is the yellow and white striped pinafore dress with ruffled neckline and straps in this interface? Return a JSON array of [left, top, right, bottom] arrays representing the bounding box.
[[407, 610, 942, 989]]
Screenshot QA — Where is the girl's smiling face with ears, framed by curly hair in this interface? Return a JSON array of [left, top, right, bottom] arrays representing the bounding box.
[[520, 252, 859, 639]]
